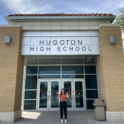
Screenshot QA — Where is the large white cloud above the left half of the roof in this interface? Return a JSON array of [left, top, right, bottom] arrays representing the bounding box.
[[1, 0, 51, 14]]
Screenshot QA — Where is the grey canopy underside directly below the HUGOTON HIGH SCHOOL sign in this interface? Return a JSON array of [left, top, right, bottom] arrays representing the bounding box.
[[25, 55, 97, 65]]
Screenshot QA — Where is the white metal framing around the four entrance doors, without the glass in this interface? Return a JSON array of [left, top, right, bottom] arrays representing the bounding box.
[[37, 78, 87, 111]]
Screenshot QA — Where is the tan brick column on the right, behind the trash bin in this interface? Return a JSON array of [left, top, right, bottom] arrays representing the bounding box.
[[97, 25, 124, 122]]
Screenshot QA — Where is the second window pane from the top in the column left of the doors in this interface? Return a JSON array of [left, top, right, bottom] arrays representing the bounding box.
[[25, 76, 37, 89]]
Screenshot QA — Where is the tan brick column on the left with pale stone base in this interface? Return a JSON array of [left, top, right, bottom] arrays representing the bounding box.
[[0, 27, 24, 122]]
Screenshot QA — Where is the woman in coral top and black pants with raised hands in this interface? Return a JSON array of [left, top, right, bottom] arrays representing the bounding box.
[[57, 88, 69, 123]]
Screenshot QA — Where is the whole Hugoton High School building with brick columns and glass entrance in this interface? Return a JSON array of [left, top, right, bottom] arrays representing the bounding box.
[[0, 13, 124, 122]]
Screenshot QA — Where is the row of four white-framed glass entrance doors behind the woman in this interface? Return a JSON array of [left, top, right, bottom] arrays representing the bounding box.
[[37, 79, 86, 111]]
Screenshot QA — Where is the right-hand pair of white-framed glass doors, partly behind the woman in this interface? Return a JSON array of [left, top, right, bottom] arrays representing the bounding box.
[[62, 79, 86, 110]]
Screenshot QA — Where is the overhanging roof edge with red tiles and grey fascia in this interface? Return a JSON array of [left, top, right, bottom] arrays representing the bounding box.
[[5, 13, 116, 22]]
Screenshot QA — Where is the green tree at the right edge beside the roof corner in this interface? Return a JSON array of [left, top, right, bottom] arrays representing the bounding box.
[[114, 8, 124, 32]]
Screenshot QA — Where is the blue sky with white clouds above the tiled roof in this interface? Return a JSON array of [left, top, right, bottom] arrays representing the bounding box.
[[0, 0, 124, 25]]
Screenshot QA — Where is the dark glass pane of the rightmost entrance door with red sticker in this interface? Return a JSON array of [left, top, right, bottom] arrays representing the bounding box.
[[75, 81, 83, 107]]
